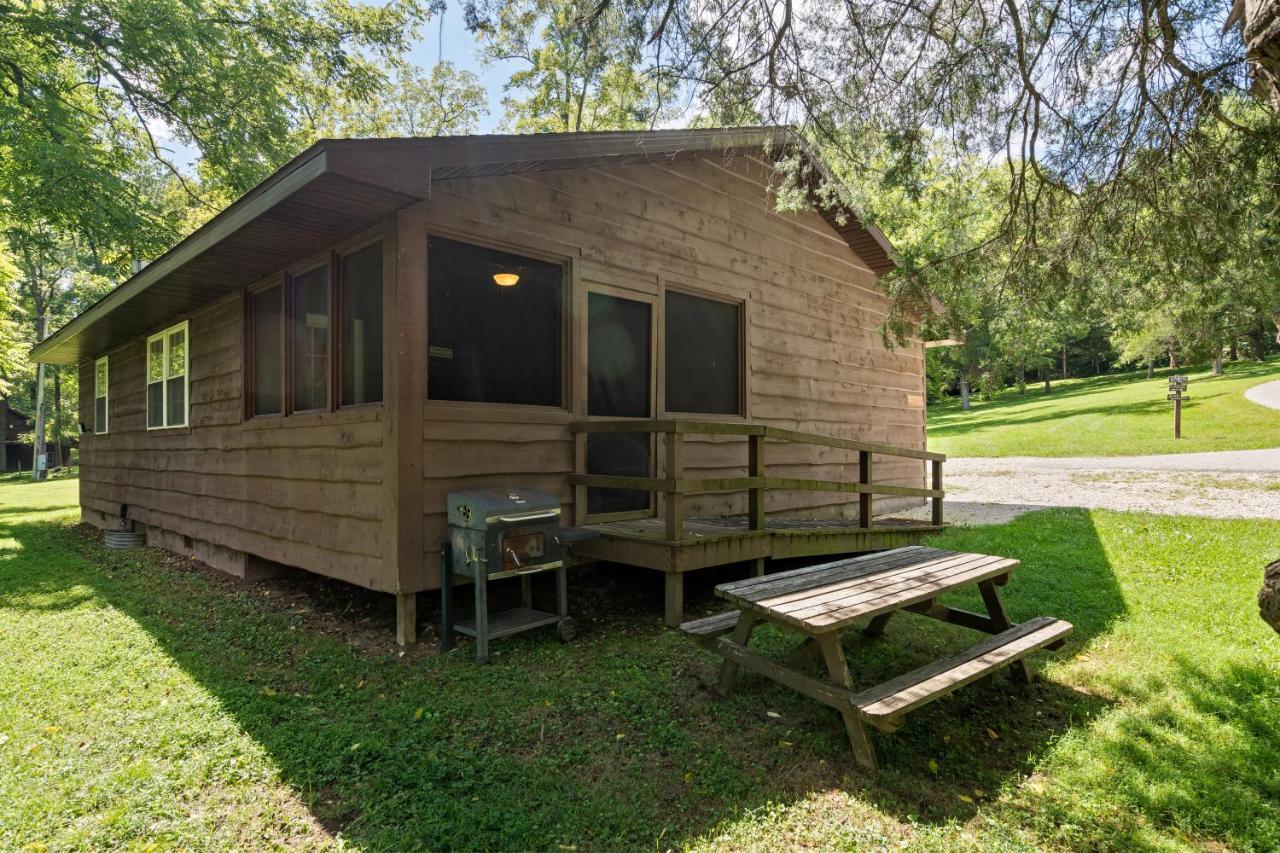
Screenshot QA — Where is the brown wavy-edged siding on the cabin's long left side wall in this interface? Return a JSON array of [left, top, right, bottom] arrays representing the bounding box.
[[81, 289, 388, 589]]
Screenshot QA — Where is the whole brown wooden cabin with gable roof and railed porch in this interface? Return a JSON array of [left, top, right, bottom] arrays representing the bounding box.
[[35, 128, 941, 640]]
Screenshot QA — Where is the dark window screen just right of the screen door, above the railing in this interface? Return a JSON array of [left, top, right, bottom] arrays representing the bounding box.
[[666, 291, 742, 415]]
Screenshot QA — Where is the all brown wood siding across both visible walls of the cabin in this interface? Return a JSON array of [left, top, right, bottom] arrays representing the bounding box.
[[81, 149, 925, 592]]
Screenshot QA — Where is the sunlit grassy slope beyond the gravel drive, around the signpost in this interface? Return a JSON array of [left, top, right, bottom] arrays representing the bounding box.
[[929, 357, 1280, 456]]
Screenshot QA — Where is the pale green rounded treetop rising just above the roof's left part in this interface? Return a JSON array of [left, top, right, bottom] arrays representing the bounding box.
[[308, 63, 486, 137]]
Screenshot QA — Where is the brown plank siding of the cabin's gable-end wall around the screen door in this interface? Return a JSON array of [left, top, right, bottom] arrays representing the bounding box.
[[416, 158, 925, 588]]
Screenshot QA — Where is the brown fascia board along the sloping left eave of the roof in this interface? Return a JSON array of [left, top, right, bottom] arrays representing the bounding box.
[[31, 150, 328, 364]]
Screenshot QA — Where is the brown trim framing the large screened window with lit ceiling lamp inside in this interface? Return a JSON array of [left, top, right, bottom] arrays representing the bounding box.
[[424, 224, 570, 409]]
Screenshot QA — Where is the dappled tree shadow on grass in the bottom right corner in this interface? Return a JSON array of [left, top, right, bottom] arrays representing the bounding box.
[[1018, 658, 1280, 850]]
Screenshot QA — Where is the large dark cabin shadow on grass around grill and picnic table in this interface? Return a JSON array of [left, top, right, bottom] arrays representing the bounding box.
[[0, 511, 1141, 849]]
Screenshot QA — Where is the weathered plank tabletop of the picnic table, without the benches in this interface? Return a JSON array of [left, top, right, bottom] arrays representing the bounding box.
[[716, 546, 1018, 634]]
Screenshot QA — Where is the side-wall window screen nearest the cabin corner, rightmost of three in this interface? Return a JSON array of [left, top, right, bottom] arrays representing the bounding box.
[[338, 243, 383, 406]]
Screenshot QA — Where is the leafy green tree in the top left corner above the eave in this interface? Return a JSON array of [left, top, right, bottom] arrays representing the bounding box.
[[0, 0, 426, 251]]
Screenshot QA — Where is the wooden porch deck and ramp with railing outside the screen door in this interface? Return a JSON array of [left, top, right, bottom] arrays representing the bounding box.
[[570, 420, 946, 628]]
